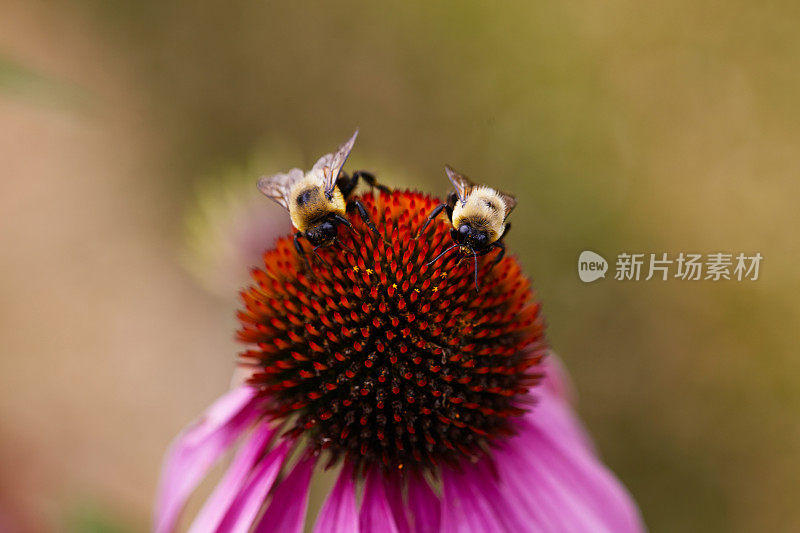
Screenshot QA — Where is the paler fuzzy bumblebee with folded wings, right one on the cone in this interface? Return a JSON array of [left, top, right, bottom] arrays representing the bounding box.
[[419, 166, 517, 291]]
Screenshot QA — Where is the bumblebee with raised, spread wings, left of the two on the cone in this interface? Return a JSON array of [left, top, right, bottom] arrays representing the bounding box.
[[258, 130, 389, 263]]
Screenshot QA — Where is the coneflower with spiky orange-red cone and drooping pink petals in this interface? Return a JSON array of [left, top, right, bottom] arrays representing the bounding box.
[[155, 192, 643, 532]]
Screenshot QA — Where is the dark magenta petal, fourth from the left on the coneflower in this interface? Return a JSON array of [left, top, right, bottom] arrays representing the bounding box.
[[255, 459, 314, 533]]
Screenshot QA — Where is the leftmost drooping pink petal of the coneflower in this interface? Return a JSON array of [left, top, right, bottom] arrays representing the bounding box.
[[153, 386, 258, 533]]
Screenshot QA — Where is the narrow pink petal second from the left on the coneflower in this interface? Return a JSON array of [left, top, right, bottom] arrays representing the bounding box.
[[189, 423, 273, 533]]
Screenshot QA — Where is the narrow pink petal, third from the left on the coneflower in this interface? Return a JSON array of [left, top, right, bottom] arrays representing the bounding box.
[[219, 441, 289, 533]]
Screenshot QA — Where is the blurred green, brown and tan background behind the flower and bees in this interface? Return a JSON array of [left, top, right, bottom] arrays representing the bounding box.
[[0, 0, 800, 532]]
